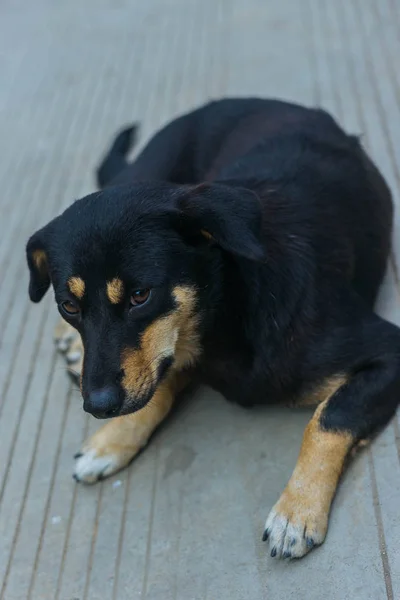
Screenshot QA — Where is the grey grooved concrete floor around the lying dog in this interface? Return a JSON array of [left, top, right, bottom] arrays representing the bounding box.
[[0, 0, 400, 600]]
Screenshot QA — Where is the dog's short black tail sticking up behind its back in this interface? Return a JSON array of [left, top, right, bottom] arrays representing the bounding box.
[[96, 124, 139, 188]]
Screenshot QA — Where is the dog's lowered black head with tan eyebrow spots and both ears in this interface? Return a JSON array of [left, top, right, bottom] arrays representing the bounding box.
[[27, 183, 263, 417]]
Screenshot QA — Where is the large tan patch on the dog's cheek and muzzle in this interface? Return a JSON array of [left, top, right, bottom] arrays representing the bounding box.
[[121, 286, 201, 395]]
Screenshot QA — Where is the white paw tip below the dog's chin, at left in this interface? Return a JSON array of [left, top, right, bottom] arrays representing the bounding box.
[[73, 449, 126, 483]]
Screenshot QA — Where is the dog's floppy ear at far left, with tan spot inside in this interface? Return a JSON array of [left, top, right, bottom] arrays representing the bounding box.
[[26, 229, 50, 302]]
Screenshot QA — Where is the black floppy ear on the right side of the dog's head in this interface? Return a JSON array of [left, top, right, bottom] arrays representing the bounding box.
[[177, 183, 265, 261]]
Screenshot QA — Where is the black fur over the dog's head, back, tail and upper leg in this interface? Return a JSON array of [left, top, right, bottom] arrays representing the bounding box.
[[27, 99, 400, 439]]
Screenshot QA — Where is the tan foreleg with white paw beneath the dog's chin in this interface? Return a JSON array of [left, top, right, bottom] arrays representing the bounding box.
[[74, 374, 188, 483]]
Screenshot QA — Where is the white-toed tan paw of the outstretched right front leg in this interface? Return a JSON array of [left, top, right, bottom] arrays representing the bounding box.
[[263, 489, 328, 558]]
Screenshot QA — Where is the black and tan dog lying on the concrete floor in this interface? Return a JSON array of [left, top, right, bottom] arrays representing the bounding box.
[[26, 98, 400, 558]]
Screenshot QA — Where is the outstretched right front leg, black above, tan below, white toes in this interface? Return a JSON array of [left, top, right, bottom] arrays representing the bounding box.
[[263, 322, 400, 558]]
